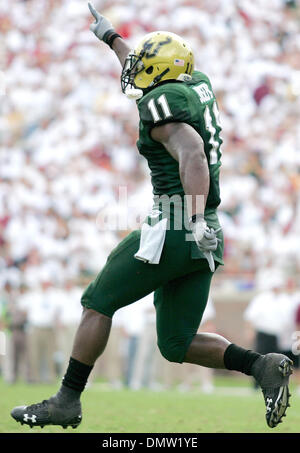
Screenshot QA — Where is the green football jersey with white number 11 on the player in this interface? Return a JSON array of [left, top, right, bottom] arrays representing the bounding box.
[[137, 71, 222, 209]]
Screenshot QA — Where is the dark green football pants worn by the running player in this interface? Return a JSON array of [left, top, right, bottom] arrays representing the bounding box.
[[81, 230, 218, 363]]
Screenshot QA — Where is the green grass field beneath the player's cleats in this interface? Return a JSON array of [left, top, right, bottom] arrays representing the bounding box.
[[0, 378, 300, 433]]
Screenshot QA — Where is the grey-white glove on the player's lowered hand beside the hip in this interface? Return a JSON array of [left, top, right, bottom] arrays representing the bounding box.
[[190, 214, 221, 272]]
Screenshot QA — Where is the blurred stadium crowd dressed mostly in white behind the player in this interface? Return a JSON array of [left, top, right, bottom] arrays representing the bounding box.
[[0, 0, 300, 384]]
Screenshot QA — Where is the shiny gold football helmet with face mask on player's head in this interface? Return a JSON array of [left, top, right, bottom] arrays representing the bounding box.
[[121, 31, 194, 94]]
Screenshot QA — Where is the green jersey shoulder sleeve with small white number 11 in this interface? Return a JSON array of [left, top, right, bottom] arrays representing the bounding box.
[[138, 83, 191, 131]]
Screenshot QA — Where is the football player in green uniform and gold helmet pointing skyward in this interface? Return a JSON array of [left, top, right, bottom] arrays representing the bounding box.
[[11, 4, 292, 428]]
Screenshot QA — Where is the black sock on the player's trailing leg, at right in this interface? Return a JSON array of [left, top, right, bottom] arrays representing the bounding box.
[[224, 343, 261, 376]]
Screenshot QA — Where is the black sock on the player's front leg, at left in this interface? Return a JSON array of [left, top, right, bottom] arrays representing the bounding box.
[[59, 357, 93, 396]]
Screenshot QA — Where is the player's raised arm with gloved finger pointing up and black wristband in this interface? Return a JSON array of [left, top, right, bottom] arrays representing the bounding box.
[[88, 3, 130, 67]]
